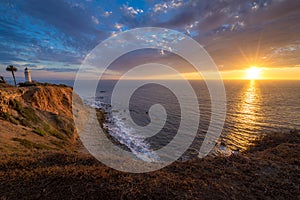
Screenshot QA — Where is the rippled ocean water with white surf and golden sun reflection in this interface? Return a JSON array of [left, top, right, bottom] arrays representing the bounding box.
[[31, 80, 300, 160]]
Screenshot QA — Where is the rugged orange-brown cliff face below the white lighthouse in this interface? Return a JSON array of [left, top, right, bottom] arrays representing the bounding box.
[[0, 84, 77, 152]]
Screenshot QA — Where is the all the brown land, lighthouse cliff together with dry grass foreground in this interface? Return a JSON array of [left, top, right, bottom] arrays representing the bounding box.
[[0, 85, 300, 200]]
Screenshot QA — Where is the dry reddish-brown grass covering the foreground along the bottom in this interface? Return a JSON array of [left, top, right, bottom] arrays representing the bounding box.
[[0, 131, 300, 199]]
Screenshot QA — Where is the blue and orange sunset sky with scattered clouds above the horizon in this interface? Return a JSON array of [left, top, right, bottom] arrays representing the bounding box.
[[0, 0, 300, 79]]
